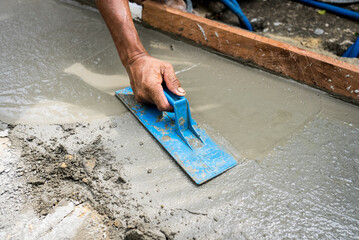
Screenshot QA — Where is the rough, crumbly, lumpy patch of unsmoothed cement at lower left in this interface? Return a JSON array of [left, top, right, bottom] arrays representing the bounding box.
[[5, 121, 175, 239]]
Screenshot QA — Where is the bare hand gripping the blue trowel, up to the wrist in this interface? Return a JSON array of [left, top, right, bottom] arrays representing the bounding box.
[[126, 54, 186, 111]]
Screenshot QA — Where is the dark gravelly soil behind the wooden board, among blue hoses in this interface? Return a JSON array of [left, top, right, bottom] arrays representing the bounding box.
[[194, 0, 359, 64]]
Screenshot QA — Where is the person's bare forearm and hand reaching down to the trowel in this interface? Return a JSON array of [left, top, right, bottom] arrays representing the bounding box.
[[96, 0, 185, 111]]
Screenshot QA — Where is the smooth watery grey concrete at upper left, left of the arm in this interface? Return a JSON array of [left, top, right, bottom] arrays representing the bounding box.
[[0, 0, 128, 123]]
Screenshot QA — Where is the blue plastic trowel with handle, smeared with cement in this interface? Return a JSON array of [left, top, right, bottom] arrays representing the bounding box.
[[116, 87, 237, 184]]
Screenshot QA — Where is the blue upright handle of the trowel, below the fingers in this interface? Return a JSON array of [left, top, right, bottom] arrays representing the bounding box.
[[164, 87, 204, 150]]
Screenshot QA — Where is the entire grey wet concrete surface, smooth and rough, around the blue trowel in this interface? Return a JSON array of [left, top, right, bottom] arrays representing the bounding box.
[[0, 0, 359, 239]]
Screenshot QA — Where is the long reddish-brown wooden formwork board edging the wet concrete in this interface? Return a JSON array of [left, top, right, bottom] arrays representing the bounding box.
[[142, 1, 359, 105]]
